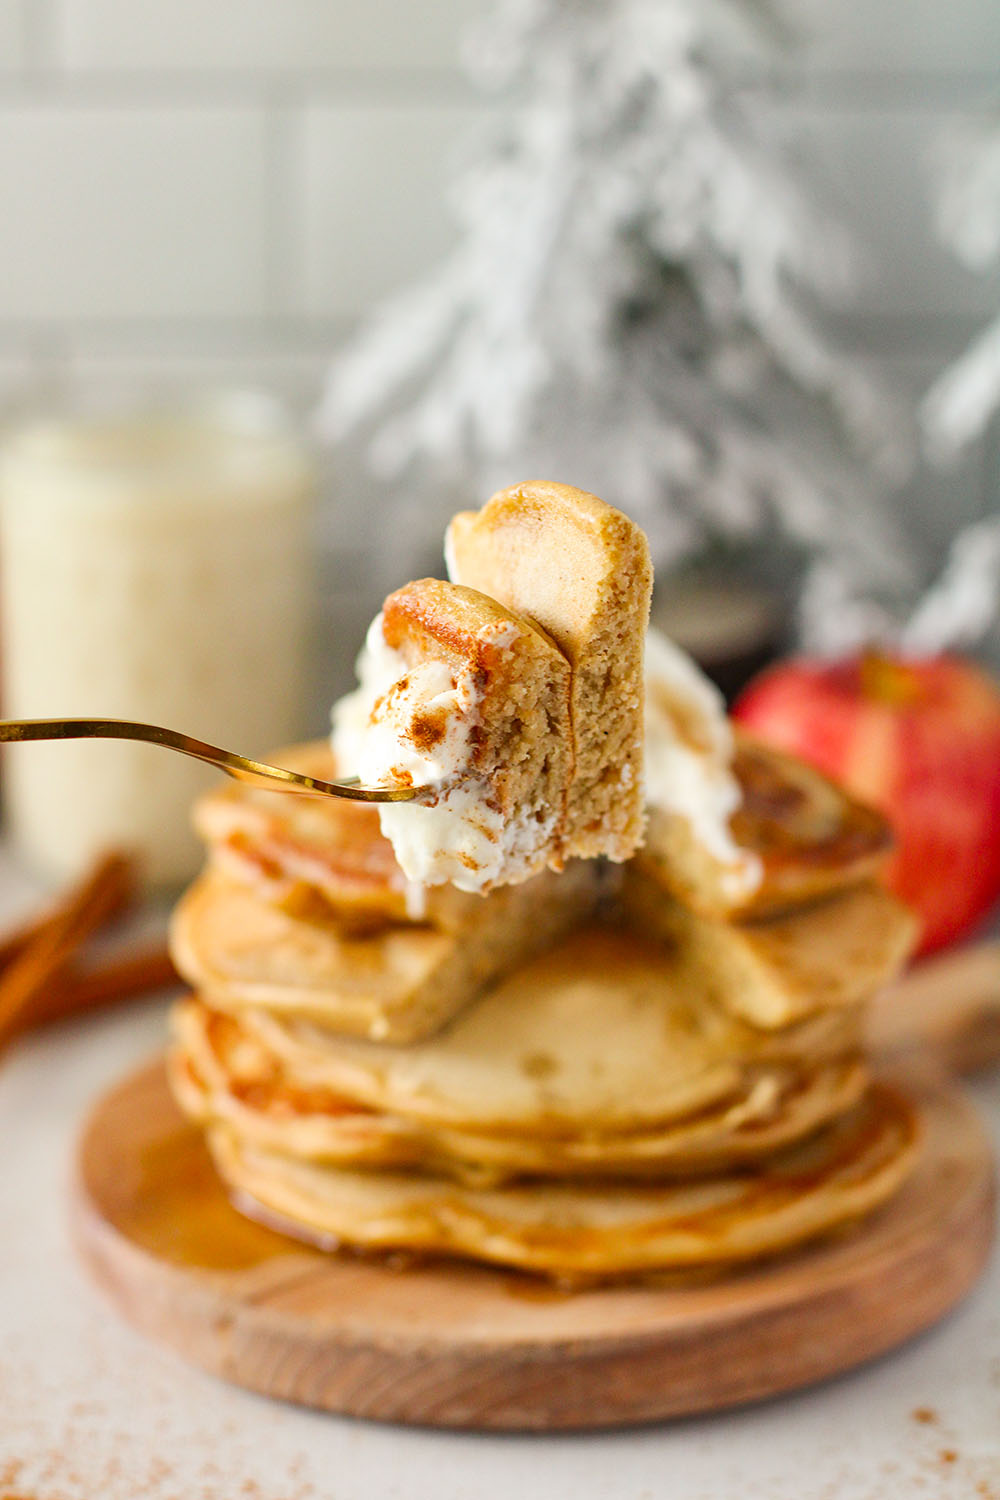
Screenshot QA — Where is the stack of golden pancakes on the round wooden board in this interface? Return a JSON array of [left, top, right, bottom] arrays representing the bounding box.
[[169, 494, 918, 1281]]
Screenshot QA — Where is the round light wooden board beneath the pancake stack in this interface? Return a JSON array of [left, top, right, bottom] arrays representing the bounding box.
[[73, 1062, 994, 1431]]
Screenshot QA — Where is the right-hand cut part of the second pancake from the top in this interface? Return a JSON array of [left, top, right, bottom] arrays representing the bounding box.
[[619, 864, 918, 1028]]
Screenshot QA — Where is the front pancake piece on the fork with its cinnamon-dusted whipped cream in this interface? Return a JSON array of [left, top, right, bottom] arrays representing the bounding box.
[[333, 578, 575, 893]]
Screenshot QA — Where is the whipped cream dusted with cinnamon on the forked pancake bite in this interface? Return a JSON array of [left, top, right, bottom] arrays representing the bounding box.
[[331, 614, 555, 888]]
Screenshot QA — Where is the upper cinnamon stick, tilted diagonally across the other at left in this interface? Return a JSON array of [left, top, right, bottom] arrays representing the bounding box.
[[0, 851, 136, 1049]]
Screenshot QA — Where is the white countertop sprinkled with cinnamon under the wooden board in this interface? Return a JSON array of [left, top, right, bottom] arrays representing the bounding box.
[[0, 863, 1000, 1500]]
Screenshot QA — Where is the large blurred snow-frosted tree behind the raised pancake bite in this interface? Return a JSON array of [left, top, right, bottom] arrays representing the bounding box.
[[321, 0, 901, 597]]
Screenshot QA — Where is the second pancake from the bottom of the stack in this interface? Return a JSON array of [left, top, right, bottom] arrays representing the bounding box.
[[169, 999, 867, 1185]]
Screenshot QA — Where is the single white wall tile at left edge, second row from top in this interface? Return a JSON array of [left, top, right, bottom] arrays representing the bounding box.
[[0, 104, 267, 326]]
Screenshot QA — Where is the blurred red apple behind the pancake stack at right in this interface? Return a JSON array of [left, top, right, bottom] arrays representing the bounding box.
[[733, 651, 1000, 954]]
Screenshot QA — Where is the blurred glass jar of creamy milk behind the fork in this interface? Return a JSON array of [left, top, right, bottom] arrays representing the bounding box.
[[0, 393, 313, 887]]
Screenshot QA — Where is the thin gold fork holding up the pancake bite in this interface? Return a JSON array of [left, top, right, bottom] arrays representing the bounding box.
[[0, 719, 429, 803]]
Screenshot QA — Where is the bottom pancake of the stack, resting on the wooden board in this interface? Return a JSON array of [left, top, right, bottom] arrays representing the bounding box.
[[208, 1086, 919, 1278]]
